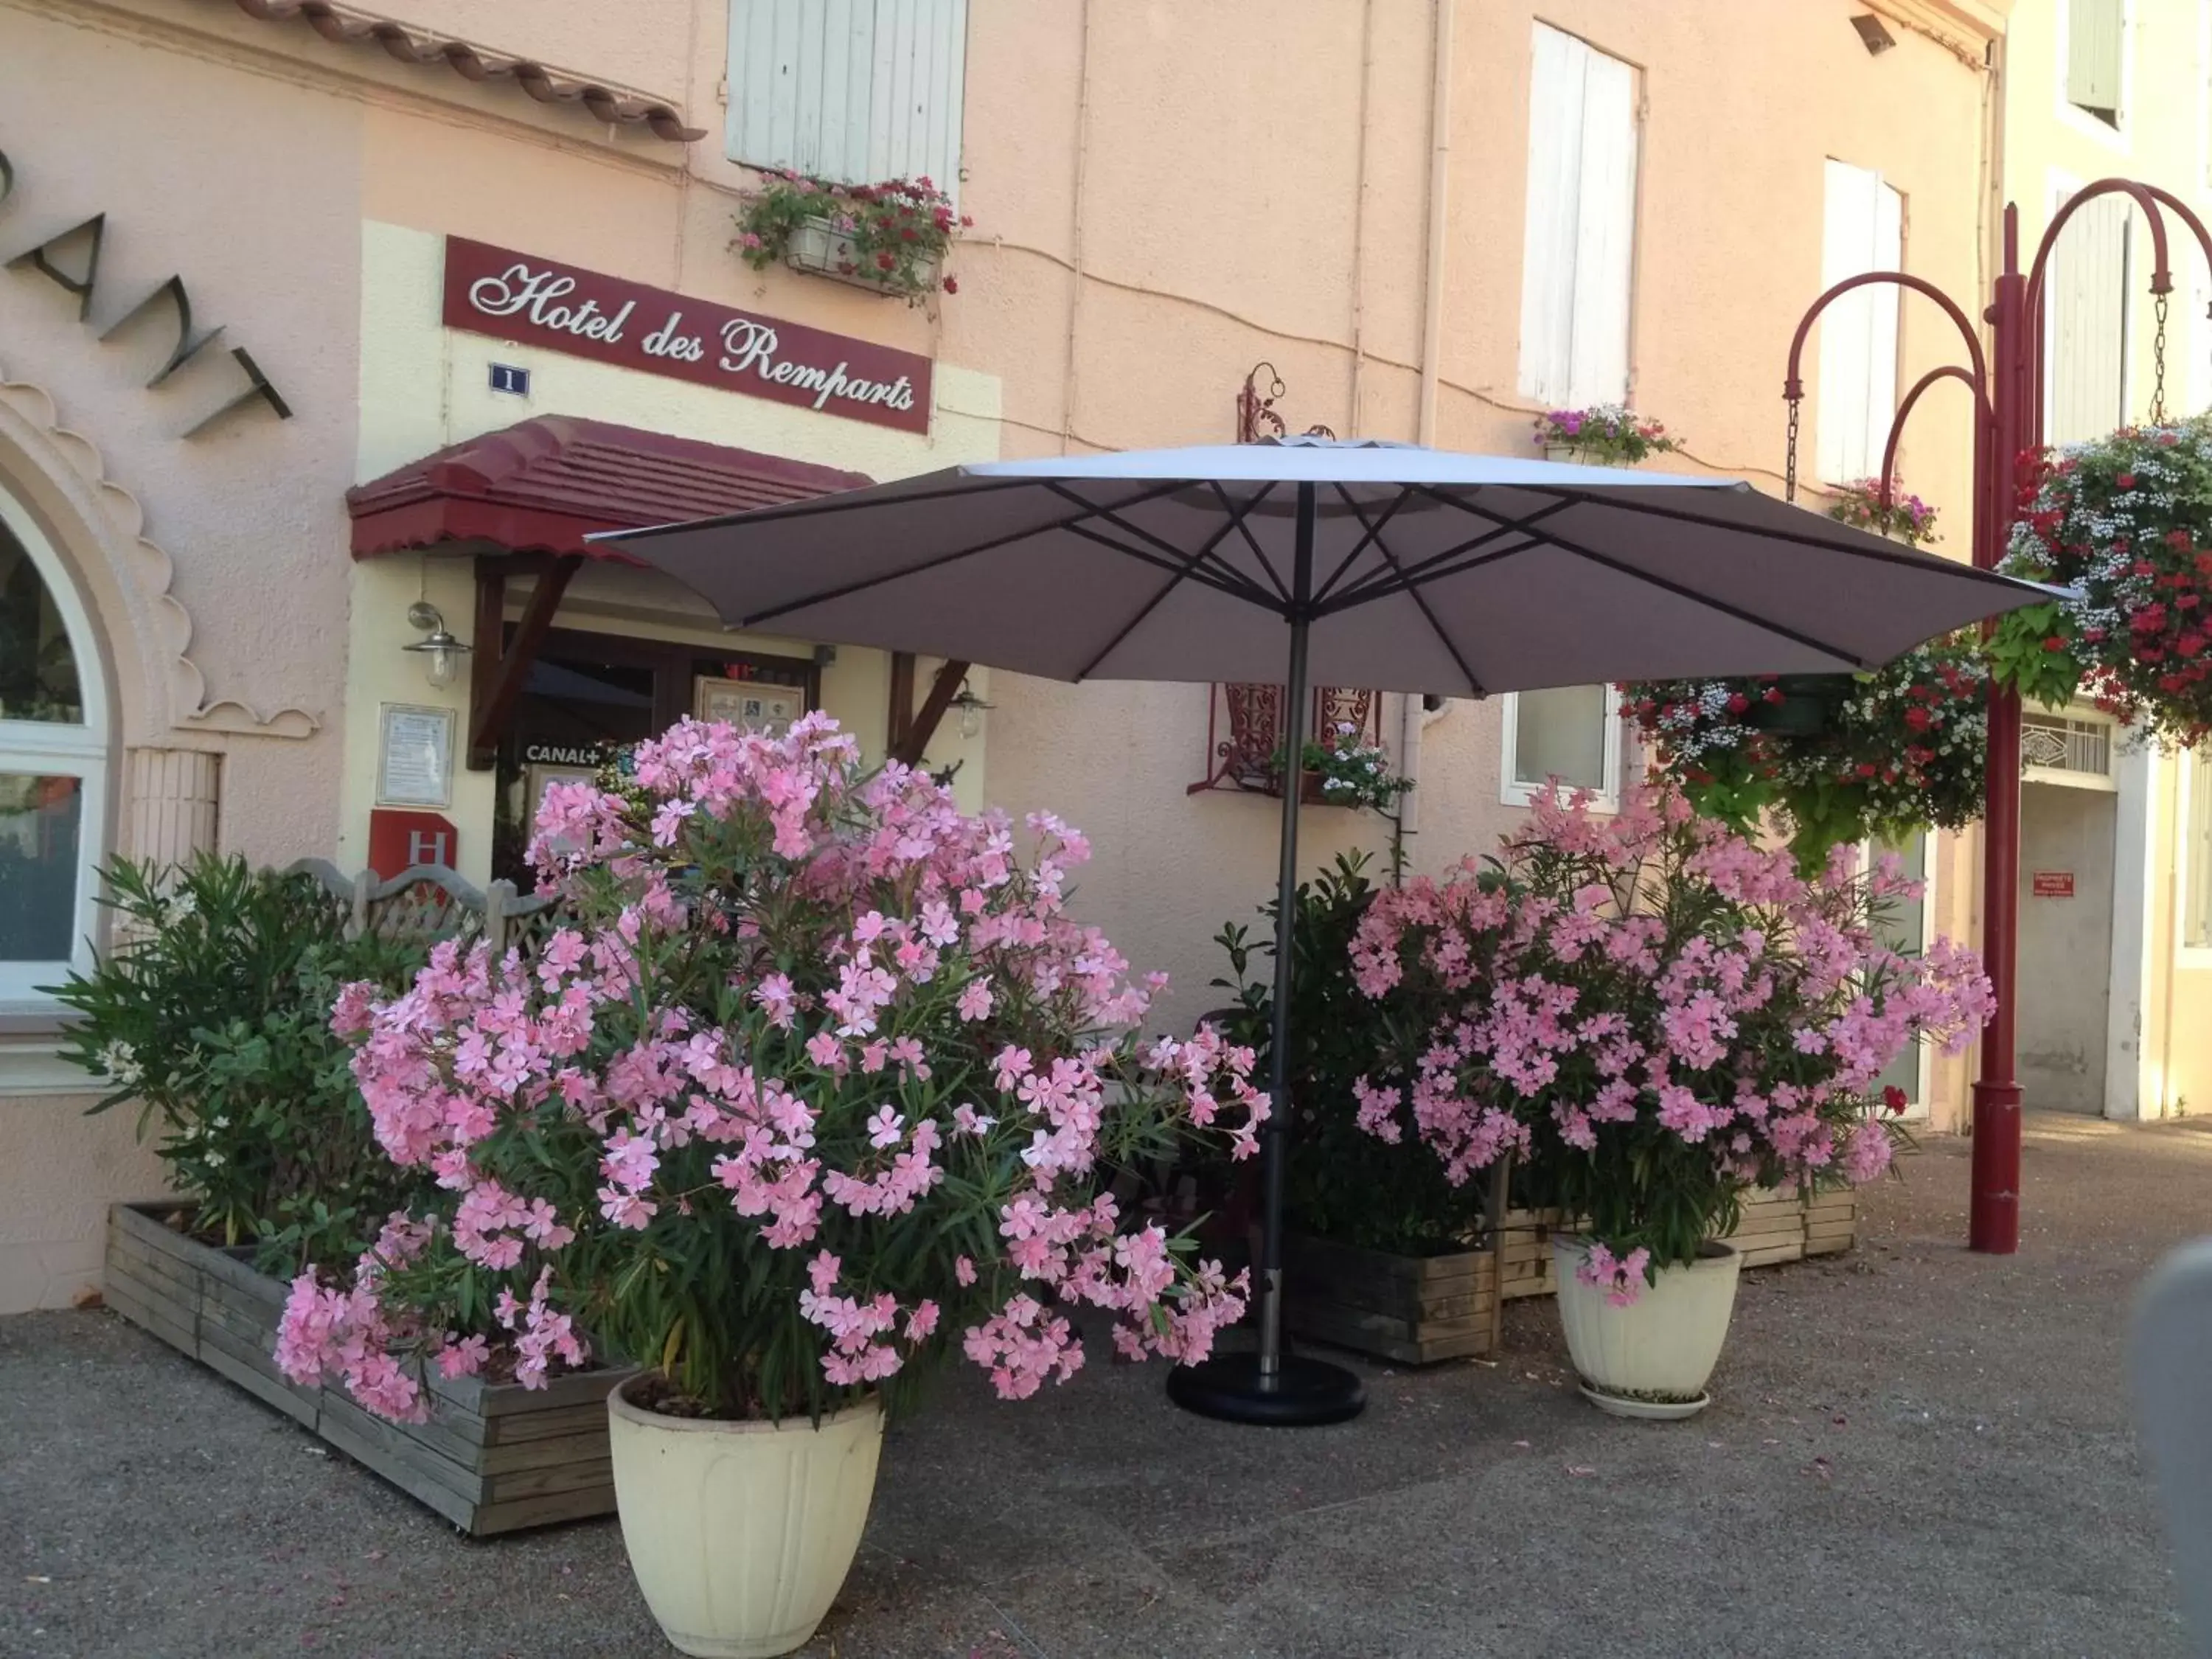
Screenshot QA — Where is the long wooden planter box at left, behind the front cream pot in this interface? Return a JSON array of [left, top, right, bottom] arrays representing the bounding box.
[[104, 1203, 630, 1537]]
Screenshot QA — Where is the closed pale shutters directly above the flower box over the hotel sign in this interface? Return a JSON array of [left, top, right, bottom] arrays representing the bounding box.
[[728, 0, 967, 195]]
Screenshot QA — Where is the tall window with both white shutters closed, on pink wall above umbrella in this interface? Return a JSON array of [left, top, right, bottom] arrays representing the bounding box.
[[1520, 24, 1637, 409]]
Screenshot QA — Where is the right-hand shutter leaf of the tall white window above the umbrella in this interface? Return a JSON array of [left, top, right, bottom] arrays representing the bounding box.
[[1566, 49, 1637, 407]]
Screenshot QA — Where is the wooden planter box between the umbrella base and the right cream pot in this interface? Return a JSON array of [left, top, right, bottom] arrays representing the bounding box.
[[1283, 1232, 1502, 1365]]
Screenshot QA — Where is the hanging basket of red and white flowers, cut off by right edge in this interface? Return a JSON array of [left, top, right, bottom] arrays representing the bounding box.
[[1989, 416, 2212, 745]]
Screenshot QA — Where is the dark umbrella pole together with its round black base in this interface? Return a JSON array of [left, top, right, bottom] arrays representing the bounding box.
[[1168, 484, 1367, 1427]]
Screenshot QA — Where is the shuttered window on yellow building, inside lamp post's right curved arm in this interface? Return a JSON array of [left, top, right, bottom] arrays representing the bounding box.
[[2044, 184, 2135, 445]]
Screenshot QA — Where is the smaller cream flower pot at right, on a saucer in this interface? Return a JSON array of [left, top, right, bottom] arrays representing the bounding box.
[[1557, 1239, 1743, 1425]]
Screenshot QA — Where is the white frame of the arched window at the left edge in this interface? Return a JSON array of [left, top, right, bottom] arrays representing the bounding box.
[[0, 489, 111, 1013]]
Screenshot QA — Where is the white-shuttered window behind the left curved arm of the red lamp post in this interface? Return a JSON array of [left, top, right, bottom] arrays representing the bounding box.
[[1814, 161, 1905, 484]]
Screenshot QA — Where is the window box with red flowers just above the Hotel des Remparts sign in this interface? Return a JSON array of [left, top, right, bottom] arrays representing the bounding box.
[[737, 170, 971, 305]]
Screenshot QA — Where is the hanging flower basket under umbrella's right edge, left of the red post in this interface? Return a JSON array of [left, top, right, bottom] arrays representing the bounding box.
[[1621, 635, 1989, 869]]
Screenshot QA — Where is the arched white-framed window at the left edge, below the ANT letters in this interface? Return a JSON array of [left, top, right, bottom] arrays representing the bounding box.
[[0, 493, 108, 1009]]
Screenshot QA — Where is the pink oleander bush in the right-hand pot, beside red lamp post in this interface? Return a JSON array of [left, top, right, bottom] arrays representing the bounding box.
[[1352, 790, 1991, 1298]]
